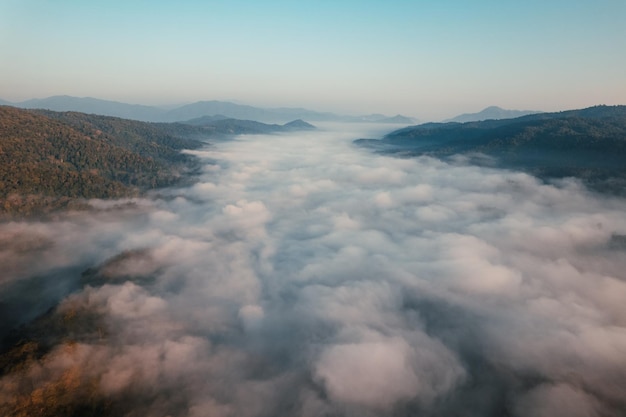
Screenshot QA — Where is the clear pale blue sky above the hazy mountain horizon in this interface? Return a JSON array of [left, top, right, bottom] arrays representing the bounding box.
[[0, 0, 626, 120]]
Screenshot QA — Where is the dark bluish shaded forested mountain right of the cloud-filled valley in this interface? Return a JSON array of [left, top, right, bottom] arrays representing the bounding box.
[[356, 106, 626, 195]]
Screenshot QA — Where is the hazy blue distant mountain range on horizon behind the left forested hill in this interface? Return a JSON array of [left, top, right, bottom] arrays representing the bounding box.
[[0, 96, 416, 124]]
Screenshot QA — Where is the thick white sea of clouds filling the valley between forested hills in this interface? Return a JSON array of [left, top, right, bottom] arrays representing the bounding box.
[[0, 125, 626, 417]]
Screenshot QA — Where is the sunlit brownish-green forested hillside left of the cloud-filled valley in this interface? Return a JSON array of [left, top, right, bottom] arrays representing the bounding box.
[[0, 106, 210, 216]]
